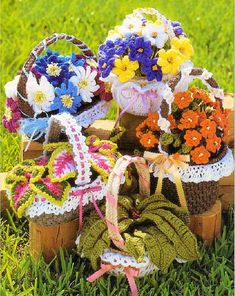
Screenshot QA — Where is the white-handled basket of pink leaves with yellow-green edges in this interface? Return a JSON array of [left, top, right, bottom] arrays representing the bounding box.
[[7, 113, 118, 228]]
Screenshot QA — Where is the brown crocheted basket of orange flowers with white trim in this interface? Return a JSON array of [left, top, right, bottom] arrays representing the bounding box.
[[136, 68, 233, 214]]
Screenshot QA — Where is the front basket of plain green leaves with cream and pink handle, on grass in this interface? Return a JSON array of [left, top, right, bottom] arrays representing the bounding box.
[[76, 156, 197, 295]]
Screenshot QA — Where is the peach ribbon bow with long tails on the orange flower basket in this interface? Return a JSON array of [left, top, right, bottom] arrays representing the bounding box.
[[144, 151, 190, 210]]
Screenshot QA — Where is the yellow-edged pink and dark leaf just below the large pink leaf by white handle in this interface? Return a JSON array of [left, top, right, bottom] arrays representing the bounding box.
[[29, 177, 71, 206]]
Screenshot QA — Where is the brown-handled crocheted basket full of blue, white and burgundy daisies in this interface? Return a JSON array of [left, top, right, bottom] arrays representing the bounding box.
[[2, 34, 112, 140]]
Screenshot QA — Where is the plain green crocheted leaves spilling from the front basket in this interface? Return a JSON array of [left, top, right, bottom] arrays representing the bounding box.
[[78, 194, 199, 272]]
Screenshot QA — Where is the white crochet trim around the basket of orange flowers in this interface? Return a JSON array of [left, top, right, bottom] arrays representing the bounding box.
[[153, 149, 234, 183]]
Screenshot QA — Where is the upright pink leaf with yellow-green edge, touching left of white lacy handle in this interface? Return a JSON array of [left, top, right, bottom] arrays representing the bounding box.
[[48, 147, 76, 182]]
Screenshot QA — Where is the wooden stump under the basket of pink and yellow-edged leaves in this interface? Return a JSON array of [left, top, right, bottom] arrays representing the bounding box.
[[29, 219, 79, 263]]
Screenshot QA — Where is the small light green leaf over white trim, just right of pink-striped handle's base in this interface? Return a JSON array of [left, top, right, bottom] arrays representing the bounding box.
[[124, 233, 145, 262]]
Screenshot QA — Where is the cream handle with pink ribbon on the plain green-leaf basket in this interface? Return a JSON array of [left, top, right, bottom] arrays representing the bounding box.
[[106, 155, 150, 251]]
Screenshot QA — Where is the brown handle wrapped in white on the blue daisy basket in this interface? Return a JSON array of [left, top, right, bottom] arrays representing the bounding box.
[[17, 33, 96, 117]]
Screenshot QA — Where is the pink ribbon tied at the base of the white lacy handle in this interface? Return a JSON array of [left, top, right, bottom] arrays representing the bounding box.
[[73, 186, 104, 232]]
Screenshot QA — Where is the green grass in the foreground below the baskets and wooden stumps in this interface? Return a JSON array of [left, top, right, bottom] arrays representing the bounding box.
[[0, 209, 234, 296]]
